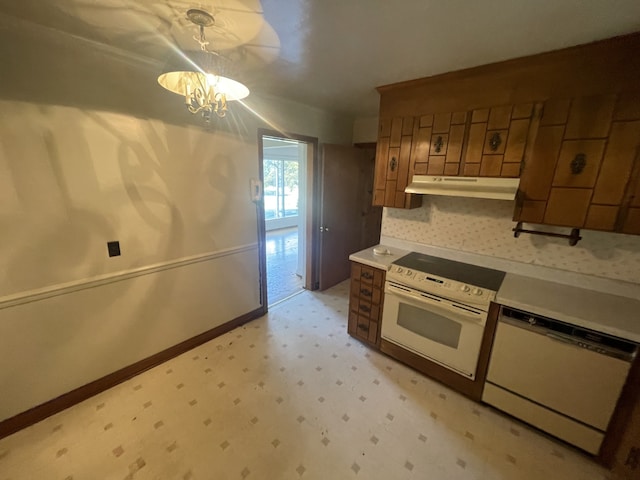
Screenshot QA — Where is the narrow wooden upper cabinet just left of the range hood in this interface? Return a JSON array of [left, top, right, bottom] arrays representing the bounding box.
[[373, 117, 422, 208]]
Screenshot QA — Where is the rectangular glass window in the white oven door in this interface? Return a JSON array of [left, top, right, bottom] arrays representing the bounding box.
[[398, 302, 462, 348]]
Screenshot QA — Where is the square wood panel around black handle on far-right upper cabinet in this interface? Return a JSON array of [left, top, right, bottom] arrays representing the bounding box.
[[553, 140, 606, 187]]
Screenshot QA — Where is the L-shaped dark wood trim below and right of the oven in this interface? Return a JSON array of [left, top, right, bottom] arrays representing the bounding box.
[[380, 302, 500, 402]]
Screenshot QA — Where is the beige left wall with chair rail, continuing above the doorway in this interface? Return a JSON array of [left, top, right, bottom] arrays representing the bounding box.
[[0, 97, 352, 420]]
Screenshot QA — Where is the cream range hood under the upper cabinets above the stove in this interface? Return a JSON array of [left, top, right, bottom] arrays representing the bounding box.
[[404, 175, 520, 200]]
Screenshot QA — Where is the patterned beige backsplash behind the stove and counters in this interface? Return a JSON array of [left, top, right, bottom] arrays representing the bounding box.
[[381, 196, 640, 284]]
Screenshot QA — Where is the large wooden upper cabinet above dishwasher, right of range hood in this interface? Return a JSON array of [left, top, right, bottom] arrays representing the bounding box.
[[514, 92, 640, 233]]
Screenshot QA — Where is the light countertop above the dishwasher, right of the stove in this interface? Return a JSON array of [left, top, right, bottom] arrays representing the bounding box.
[[496, 273, 640, 343]]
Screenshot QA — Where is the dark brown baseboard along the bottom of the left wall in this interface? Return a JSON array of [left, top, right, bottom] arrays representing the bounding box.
[[0, 308, 263, 439]]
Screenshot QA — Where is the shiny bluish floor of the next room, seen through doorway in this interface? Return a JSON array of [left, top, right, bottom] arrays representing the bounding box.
[[266, 228, 304, 305]]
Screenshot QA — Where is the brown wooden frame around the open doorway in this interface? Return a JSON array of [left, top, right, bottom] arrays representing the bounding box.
[[256, 128, 320, 313]]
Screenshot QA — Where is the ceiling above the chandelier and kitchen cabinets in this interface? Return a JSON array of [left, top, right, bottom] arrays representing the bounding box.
[[0, 0, 640, 117]]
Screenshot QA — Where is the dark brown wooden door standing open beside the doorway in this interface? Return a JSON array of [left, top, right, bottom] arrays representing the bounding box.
[[319, 144, 382, 290]]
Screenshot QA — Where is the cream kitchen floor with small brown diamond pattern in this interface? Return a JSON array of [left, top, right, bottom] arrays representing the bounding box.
[[0, 282, 608, 480]]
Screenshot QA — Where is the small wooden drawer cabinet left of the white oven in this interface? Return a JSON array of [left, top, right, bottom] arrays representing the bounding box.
[[348, 262, 385, 348]]
